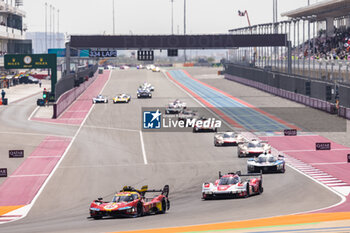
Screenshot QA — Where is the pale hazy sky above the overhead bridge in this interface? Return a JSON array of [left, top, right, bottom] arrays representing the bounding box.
[[23, 0, 316, 34]]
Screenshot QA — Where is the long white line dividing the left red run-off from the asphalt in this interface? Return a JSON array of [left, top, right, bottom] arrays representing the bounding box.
[[2, 71, 112, 222]]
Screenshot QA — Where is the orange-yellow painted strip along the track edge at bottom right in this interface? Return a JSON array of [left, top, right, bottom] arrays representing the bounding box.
[[108, 212, 350, 233]]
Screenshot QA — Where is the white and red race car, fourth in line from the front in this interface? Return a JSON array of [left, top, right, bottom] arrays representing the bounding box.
[[237, 139, 271, 157]]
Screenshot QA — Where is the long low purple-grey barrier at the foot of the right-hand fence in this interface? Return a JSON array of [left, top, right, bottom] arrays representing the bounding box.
[[225, 74, 350, 119]]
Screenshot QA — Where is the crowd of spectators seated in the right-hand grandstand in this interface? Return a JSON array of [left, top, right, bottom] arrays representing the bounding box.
[[294, 27, 350, 60]]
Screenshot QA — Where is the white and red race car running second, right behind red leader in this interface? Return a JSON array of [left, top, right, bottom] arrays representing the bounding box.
[[202, 171, 264, 200]]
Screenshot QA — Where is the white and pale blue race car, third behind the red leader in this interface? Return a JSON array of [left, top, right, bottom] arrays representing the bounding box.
[[247, 153, 286, 173]]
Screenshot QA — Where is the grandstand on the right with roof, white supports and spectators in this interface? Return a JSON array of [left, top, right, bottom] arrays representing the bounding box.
[[229, 0, 350, 83]]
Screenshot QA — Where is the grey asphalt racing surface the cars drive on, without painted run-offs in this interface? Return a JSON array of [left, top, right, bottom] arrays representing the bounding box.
[[0, 69, 340, 233]]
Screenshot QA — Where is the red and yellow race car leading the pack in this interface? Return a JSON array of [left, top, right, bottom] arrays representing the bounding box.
[[89, 185, 170, 219]]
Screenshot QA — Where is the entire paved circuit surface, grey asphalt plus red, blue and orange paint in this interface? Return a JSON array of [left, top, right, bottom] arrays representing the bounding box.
[[0, 68, 350, 233]]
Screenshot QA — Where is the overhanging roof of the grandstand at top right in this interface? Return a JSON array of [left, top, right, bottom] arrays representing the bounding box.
[[281, 0, 350, 21]]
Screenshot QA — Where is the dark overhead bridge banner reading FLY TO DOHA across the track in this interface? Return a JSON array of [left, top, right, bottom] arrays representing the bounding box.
[[69, 34, 288, 50]]
